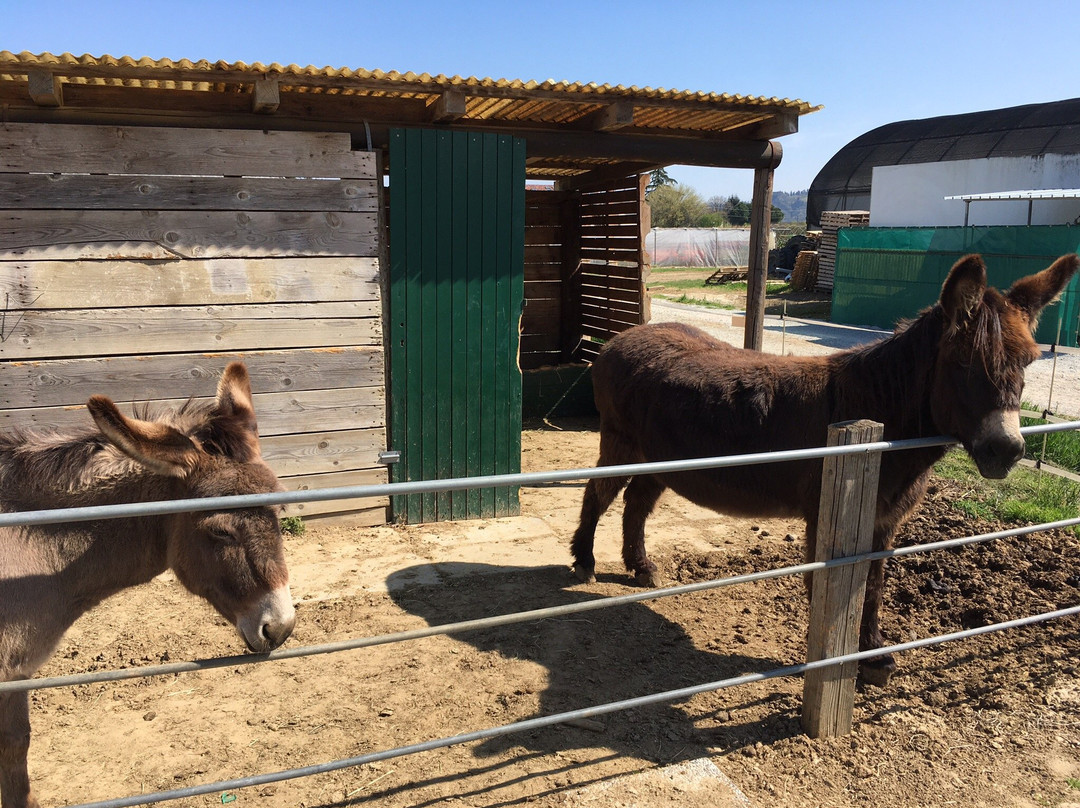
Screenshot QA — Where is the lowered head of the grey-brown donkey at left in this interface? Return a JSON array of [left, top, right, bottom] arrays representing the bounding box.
[[86, 362, 296, 651]]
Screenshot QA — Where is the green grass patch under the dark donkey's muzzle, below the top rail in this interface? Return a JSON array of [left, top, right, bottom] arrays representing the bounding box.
[[934, 449, 1080, 536]]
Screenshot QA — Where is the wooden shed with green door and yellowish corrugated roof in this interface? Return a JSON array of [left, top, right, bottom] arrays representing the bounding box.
[[0, 52, 816, 524]]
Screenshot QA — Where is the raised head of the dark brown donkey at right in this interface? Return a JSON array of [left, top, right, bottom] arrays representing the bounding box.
[[931, 255, 1080, 479]]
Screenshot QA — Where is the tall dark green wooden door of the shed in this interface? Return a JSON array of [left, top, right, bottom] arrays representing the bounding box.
[[387, 130, 525, 523]]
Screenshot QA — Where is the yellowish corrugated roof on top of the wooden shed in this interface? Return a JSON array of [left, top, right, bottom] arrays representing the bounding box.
[[0, 51, 820, 176]]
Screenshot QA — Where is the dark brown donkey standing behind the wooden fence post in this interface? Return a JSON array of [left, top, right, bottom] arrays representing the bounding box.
[[571, 255, 1080, 684]]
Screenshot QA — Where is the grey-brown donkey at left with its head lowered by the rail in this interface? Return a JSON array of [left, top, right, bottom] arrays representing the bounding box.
[[0, 362, 296, 808]]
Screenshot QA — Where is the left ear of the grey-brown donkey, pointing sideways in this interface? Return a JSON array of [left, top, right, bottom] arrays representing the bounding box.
[[86, 395, 199, 477]]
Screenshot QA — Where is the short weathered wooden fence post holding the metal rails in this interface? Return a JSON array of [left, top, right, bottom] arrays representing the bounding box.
[[802, 420, 883, 738]]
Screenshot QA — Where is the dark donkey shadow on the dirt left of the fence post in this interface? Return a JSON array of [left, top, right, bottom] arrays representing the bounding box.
[[387, 563, 797, 765]]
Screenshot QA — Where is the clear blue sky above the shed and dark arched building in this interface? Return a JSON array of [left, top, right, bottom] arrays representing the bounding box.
[[8, 0, 1080, 199]]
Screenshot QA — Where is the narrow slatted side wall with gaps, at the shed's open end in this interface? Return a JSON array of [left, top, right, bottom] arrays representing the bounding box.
[[578, 175, 648, 361]]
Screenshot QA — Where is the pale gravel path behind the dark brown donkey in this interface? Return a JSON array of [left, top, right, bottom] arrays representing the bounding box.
[[652, 300, 1080, 416]]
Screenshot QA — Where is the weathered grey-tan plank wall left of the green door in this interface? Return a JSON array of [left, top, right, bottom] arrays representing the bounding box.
[[0, 119, 387, 524]]
